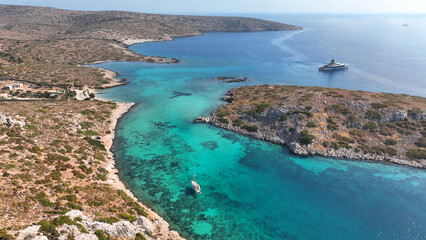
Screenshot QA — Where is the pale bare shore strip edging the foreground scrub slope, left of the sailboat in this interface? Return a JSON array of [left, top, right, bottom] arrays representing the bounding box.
[[102, 99, 184, 240]]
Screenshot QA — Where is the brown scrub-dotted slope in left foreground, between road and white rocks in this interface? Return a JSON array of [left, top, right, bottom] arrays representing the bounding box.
[[0, 101, 146, 230]]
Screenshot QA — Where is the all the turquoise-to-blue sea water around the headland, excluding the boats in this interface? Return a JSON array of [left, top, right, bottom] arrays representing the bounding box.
[[97, 15, 426, 240]]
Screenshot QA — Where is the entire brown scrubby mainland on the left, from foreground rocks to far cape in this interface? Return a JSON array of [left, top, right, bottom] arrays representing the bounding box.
[[0, 5, 300, 239]]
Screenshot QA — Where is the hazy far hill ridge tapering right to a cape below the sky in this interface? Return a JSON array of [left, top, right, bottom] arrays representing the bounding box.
[[0, 5, 300, 41]]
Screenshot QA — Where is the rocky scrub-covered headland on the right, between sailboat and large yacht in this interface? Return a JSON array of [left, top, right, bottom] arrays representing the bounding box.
[[195, 85, 426, 168]]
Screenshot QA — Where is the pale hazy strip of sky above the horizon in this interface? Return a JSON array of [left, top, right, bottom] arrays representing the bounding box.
[[0, 0, 426, 13]]
